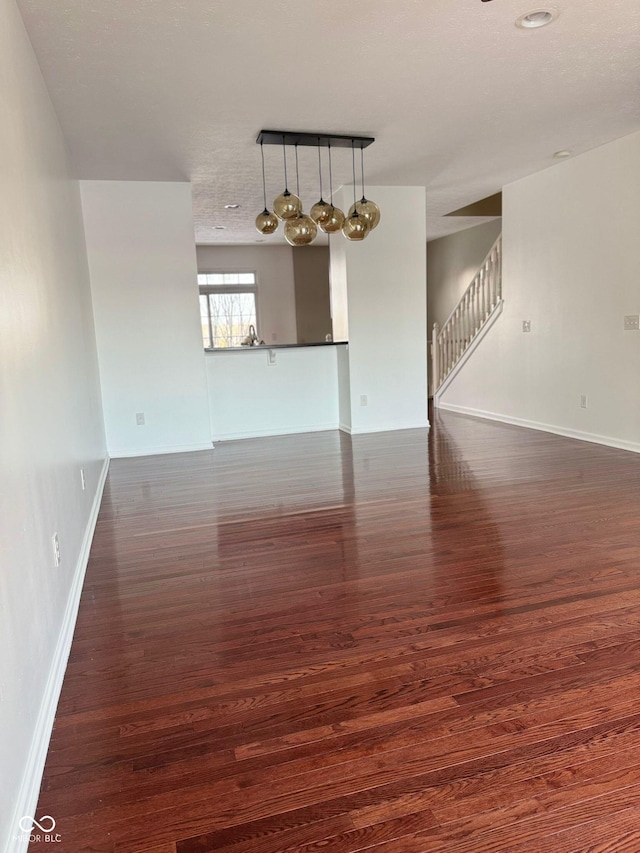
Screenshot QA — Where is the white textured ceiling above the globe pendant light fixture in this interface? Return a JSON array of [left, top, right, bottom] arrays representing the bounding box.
[[13, 0, 640, 244]]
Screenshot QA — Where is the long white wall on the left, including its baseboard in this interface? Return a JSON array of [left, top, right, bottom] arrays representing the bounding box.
[[0, 0, 106, 851]]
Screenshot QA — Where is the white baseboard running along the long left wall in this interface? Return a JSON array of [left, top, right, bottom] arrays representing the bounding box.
[[4, 457, 109, 853]]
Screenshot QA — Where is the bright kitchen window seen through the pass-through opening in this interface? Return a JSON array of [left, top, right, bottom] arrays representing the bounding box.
[[198, 272, 258, 349]]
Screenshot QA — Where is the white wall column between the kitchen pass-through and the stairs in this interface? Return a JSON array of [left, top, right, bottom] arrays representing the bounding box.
[[330, 187, 428, 433]]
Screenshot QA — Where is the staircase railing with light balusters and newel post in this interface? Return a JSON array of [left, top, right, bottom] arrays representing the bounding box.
[[431, 235, 502, 402]]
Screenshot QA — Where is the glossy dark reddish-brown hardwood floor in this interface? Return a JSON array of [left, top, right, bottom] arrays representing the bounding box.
[[31, 414, 640, 853]]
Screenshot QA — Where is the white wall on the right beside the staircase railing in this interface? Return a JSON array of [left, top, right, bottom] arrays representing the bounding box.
[[442, 134, 640, 450]]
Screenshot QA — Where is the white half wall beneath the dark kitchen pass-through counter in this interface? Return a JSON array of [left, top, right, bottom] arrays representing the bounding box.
[[207, 346, 344, 440]]
